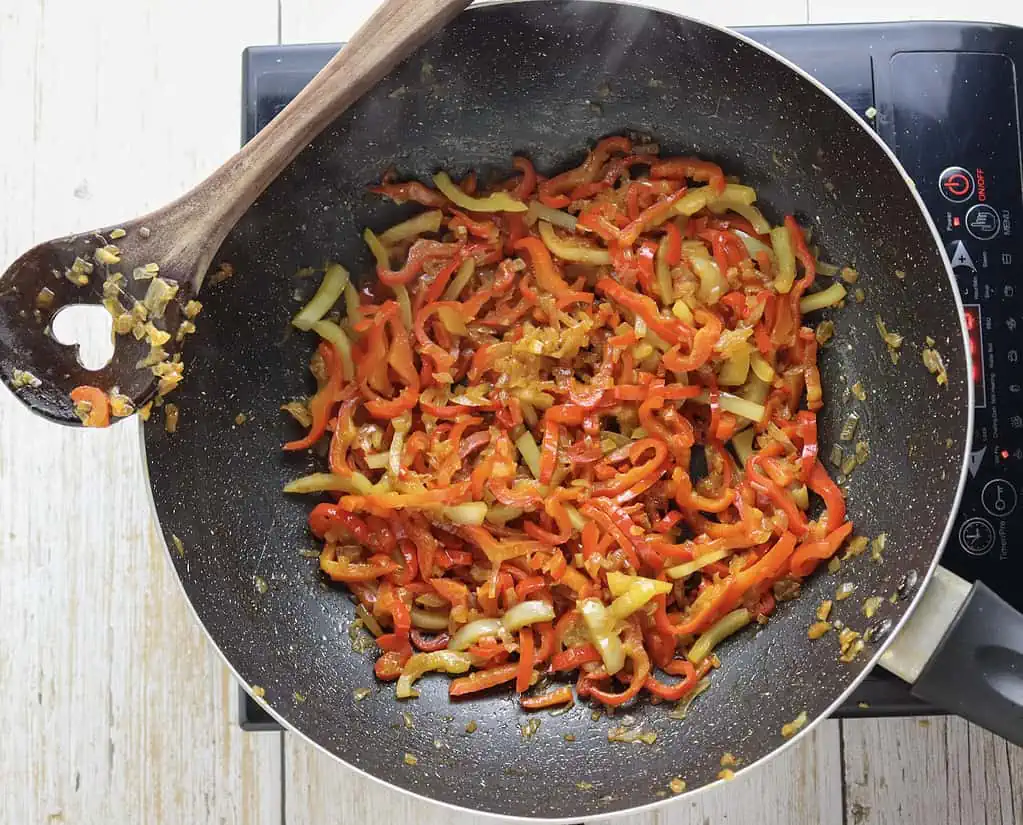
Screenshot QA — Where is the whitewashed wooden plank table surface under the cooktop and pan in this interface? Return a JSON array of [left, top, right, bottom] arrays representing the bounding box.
[[0, 0, 1023, 825]]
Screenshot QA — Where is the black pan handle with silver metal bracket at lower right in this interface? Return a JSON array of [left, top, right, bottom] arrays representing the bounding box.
[[881, 567, 1023, 745]]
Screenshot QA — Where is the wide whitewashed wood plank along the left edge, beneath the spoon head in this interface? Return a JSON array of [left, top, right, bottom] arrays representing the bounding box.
[[0, 0, 281, 825]]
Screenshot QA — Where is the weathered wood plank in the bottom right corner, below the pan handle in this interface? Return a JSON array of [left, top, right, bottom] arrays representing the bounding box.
[[842, 717, 1023, 825]]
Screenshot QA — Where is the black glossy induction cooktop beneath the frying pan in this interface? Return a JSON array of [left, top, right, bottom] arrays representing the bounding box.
[[240, 23, 1023, 730]]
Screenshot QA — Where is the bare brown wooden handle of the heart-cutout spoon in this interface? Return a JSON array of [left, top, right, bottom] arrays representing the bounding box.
[[164, 0, 472, 292]]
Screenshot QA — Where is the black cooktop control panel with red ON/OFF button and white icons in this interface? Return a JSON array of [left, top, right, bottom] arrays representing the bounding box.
[[879, 51, 1023, 608]]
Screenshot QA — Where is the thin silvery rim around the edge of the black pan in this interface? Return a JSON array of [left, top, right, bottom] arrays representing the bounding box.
[[136, 0, 975, 825]]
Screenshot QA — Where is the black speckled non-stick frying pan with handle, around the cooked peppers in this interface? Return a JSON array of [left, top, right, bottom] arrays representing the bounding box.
[[0, 0, 1023, 820]]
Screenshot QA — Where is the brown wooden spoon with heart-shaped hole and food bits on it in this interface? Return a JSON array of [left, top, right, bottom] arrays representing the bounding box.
[[0, 0, 471, 424]]
